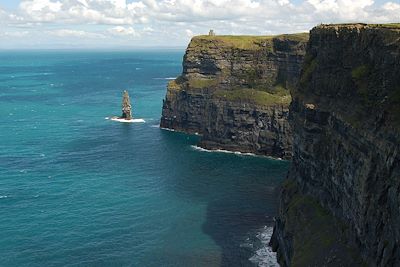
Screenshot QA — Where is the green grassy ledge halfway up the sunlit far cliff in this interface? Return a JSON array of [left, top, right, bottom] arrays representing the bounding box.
[[213, 89, 291, 106]]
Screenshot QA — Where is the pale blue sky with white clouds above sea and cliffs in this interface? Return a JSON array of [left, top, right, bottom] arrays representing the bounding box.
[[0, 0, 400, 49]]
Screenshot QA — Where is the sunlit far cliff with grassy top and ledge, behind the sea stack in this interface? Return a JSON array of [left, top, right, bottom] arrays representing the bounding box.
[[161, 34, 308, 159]]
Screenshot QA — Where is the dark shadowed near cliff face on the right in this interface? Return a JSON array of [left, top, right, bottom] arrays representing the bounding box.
[[271, 24, 400, 266]]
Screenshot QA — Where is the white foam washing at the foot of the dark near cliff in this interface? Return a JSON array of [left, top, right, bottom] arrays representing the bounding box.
[[249, 226, 279, 267]]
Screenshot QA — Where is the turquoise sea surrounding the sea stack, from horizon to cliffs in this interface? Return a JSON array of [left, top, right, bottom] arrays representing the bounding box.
[[0, 51, 288, 266]]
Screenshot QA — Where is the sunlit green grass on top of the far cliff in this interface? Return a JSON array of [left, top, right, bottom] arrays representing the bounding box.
[[191, 33, 309, 50]]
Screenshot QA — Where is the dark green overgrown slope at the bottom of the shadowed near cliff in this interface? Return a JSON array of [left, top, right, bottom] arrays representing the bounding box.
[[284, 180, 364, 266]]
